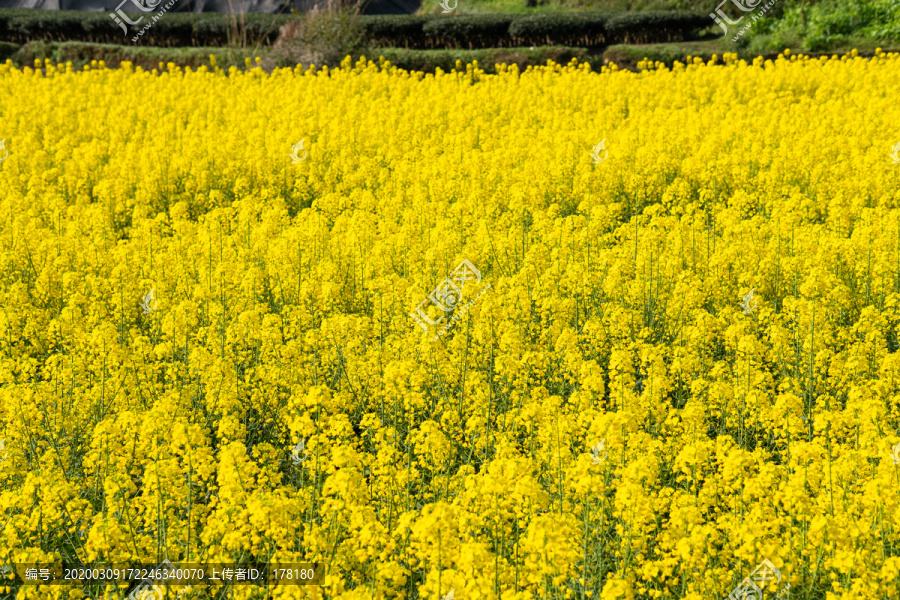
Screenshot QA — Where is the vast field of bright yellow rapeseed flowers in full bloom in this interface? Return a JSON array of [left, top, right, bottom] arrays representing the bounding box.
[[0, 51, 900, 600]]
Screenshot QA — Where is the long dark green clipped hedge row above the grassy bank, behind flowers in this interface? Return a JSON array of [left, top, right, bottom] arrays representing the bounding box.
[[0, 9, 712, 49]]
